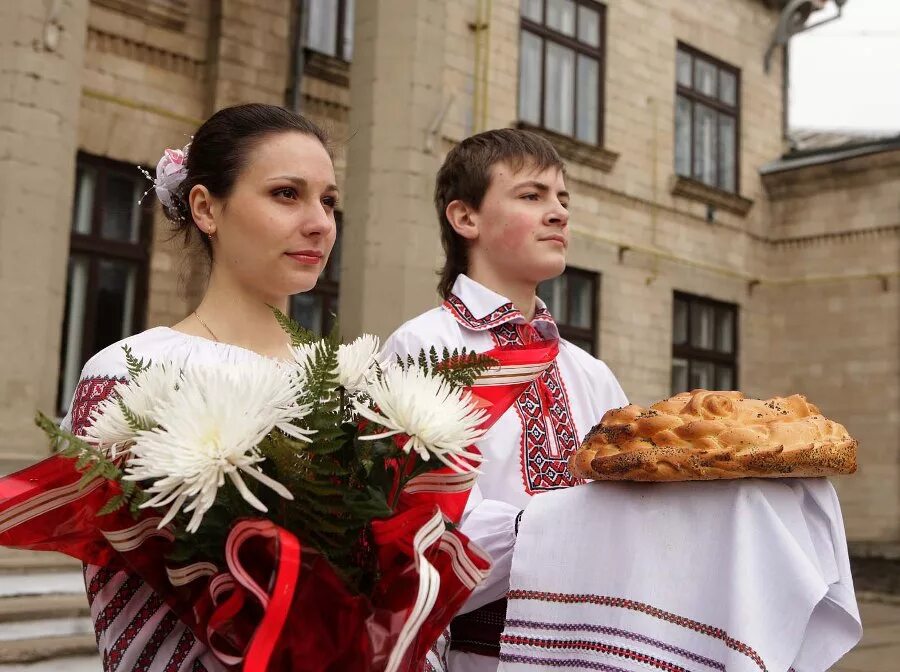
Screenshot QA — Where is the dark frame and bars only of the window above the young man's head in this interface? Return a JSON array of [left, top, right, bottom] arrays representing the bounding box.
[[516, 0, 607, 147]]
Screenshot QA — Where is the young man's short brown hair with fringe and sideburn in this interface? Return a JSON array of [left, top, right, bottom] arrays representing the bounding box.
[[434, 128, 565, 299]]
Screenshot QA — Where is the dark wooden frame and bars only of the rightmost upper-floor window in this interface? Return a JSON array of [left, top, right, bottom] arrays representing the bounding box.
[[672, 40, 742, 195]]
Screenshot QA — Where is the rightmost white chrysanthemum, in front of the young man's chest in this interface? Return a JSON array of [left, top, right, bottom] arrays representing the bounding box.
[[355, 366, 486, 473]]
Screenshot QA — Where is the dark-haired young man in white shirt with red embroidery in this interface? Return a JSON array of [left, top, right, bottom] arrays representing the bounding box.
[[385, 129, 628, 672]]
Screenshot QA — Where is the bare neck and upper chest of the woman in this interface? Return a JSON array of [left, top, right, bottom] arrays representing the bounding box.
[[173, 268, 289, 357]]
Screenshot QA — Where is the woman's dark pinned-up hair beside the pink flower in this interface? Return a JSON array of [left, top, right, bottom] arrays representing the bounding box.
[[163, 103, 331, 259]]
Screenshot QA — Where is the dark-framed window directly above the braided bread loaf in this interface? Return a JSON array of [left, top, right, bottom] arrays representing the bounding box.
[[672, 293, 738, 394]]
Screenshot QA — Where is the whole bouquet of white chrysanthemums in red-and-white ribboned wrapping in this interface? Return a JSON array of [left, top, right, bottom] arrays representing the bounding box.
[[0, 313, 560, 671]]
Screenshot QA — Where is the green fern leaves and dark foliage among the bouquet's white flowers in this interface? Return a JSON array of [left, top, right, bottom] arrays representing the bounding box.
[[36, 308, 497, 593]]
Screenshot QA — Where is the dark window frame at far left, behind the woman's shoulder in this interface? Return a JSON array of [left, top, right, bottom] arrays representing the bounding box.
[[57, 151, 153, 412]]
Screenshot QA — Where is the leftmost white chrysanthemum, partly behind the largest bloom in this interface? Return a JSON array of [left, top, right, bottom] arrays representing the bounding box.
[[84, 363, 181, 452]]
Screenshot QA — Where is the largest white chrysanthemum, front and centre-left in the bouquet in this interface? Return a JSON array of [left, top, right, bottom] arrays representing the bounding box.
[[125, 359, 312, 532]]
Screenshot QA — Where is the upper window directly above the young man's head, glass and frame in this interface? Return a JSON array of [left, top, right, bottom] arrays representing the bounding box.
[[519, 0, 606, 145]]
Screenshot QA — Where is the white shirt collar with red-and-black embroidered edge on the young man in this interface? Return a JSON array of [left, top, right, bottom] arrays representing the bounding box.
[[443, 274, 559, 340]]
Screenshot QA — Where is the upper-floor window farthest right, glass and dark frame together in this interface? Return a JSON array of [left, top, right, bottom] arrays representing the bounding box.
[[675, 44, 740, 192]]
